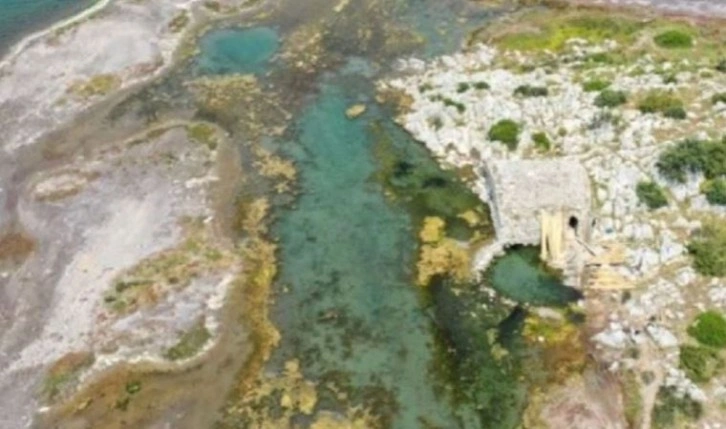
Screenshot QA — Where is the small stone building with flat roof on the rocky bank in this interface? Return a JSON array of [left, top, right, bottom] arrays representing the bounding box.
[[484, 158, 594, 283]]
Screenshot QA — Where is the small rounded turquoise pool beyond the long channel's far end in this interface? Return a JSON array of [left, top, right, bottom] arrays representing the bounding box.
[[197, 27, 280, 74]]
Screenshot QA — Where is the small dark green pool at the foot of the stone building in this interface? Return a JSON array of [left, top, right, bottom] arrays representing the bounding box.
[[486, 246, 582, 306]]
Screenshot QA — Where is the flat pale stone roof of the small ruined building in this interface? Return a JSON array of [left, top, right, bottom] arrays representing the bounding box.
[[485, 158, 591, 244]]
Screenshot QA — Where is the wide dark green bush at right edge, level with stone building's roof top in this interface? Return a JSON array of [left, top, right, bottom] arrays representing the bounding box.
[[656, 138, 726, 183]]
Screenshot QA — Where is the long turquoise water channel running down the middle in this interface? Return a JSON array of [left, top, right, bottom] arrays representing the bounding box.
[[273, 77, 486, 428]]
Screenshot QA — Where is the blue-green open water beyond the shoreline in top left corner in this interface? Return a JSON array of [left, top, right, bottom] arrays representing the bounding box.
[[0, 0, 96, 54]]
